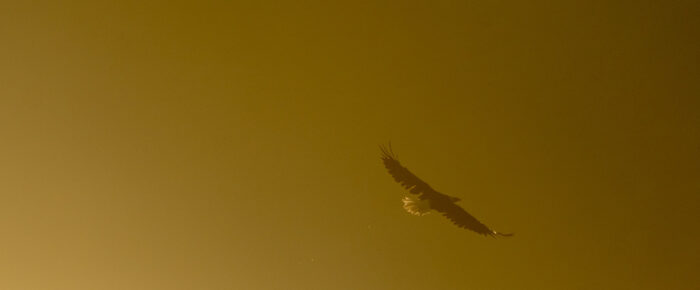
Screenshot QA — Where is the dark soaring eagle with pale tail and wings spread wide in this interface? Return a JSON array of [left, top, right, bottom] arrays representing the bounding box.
[[380, 144, 513, 237]]
